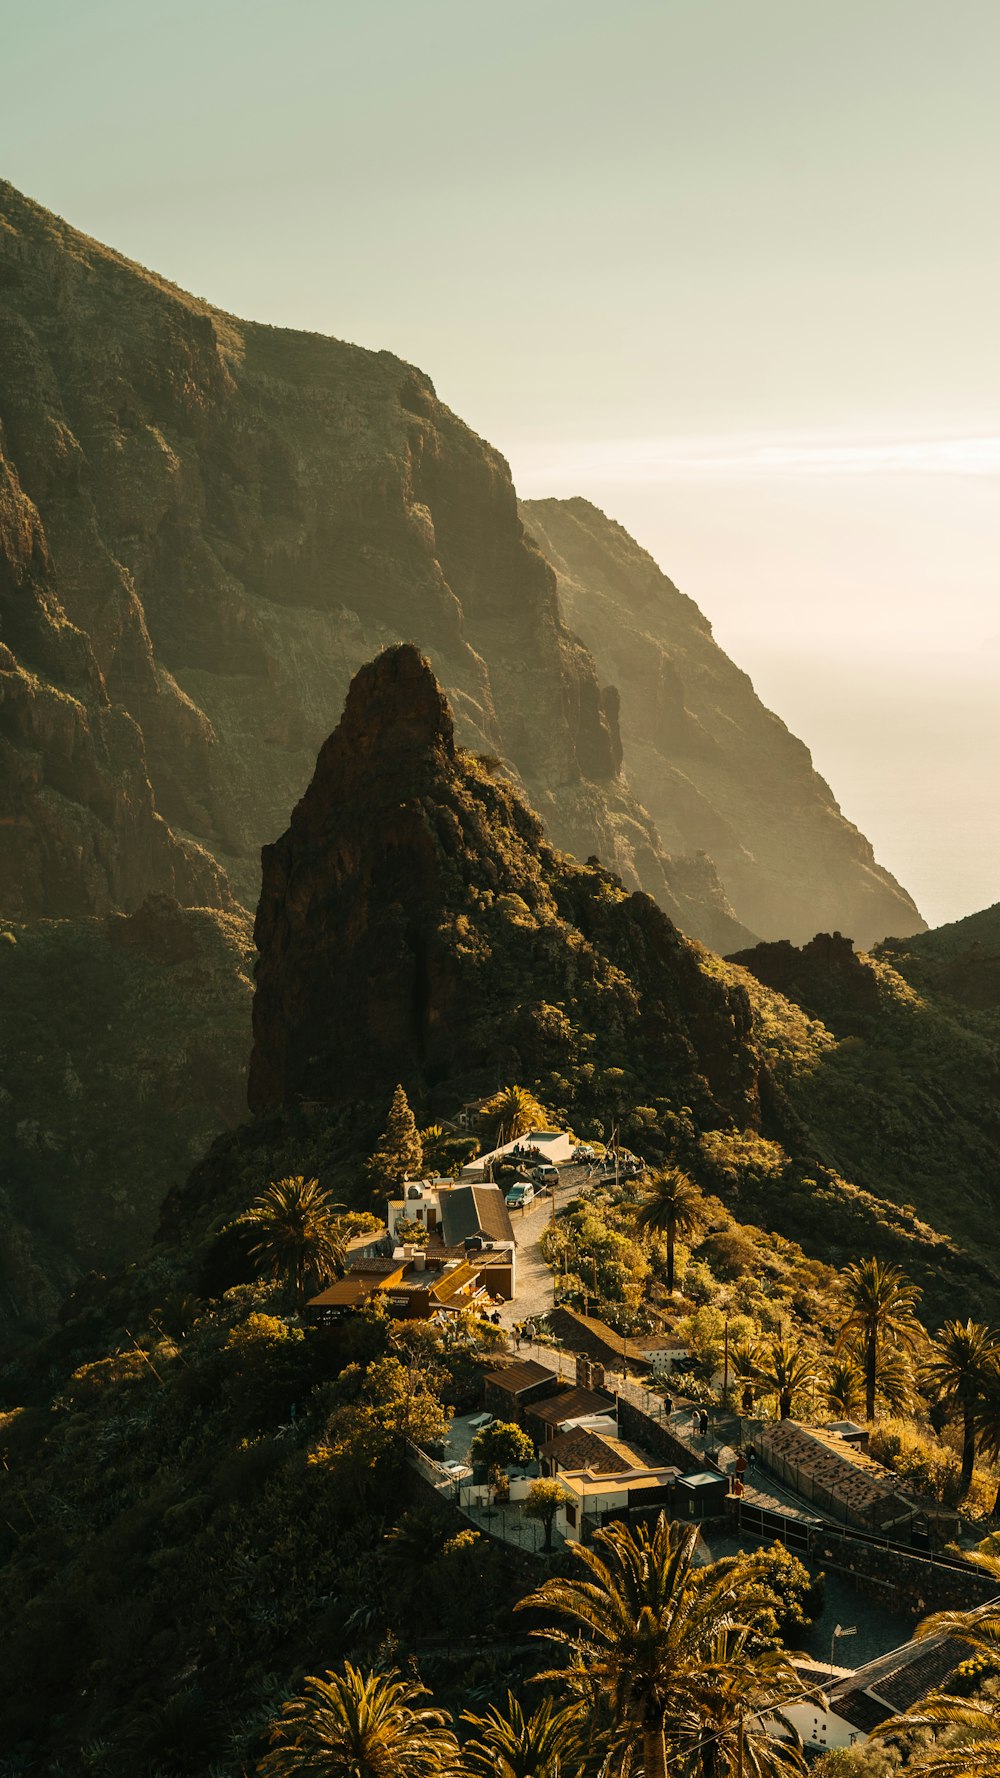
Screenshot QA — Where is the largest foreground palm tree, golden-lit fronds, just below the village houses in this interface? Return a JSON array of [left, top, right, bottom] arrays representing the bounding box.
[[516, 1515, 786, 1778]]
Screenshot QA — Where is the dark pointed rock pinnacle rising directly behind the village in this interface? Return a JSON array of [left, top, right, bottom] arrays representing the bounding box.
[[249, 645, 758, 1120]]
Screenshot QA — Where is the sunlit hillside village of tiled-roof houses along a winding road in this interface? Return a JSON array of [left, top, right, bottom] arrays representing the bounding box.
[[306, 1129, 996, 1753]]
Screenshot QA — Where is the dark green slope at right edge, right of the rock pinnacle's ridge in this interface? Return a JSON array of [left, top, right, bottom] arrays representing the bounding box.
[[722, 909, 1000, 1287]]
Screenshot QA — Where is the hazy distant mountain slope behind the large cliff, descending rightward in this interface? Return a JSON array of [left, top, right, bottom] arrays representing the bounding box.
[[521, 500, 923, 946]]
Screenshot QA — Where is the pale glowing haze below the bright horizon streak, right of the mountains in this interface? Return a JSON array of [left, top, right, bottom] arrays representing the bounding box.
[[523, 464, 1000, 926]]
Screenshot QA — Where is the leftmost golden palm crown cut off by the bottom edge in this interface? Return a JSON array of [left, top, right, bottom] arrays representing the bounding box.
[[256, 1661, 457, 1778]]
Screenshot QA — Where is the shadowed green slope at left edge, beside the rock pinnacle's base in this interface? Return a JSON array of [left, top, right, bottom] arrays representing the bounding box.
[[0, 894, 253, 1335]]
